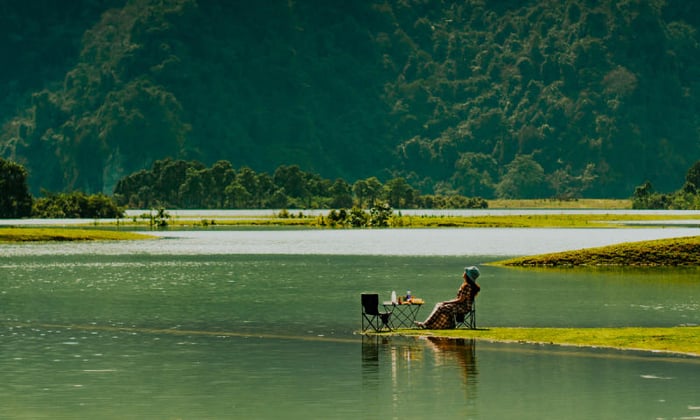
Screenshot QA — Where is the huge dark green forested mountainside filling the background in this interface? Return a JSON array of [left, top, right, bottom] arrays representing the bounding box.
[[0, 0, 700, 198]]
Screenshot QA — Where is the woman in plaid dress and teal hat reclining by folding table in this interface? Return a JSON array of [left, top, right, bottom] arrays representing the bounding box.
[[416, 266, 481, 330]]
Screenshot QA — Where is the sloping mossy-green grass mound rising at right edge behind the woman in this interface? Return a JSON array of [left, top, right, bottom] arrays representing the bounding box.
[[491, 236, 700, 267]]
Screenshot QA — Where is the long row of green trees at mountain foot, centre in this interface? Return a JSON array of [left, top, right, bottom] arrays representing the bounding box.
[[114, 159, 488, 209]]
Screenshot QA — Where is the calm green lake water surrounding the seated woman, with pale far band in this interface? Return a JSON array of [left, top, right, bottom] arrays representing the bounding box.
[[0, 228, 700, 419]]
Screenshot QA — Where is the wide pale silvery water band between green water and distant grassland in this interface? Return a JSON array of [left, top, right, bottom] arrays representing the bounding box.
[[2, 227, 700, 256]]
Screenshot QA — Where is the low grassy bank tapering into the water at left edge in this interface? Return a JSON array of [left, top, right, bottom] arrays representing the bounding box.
[[0, 228, 156, 242]]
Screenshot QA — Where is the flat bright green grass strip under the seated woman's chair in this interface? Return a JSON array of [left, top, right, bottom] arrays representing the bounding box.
[[392, 326, 700, 357]]
